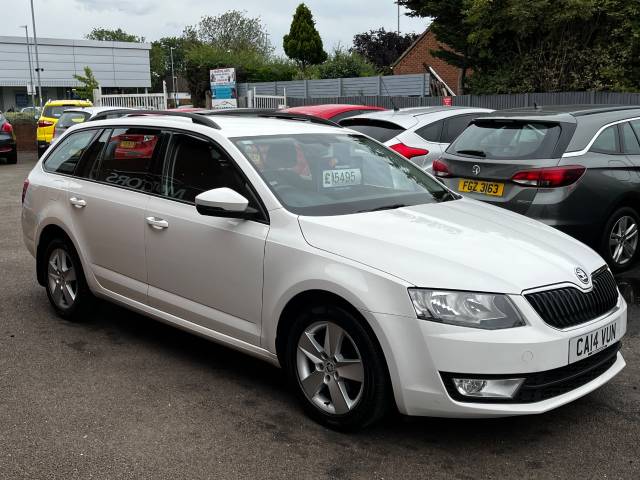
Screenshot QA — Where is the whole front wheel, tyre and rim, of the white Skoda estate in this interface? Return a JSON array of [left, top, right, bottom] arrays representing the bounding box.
[[285, 305, 391, 430]]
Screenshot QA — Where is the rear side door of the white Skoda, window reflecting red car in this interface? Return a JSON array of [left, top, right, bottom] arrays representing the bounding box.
[[69, 127, 167, 303]]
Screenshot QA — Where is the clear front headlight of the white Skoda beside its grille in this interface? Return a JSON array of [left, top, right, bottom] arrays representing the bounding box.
[[409, 288, 525, 330]]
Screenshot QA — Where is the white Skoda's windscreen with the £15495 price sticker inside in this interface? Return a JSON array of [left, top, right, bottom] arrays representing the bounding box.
[[232, 133, 454, 215]]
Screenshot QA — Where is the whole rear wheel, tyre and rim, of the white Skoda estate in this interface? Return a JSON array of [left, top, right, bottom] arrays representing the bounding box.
[[41, 238, 94, 321]]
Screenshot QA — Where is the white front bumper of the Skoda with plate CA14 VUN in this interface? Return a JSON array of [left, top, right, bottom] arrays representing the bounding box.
[[370, 295, 627, 418]]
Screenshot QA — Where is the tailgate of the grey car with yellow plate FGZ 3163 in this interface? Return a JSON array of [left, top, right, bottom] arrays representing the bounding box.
[[443, 120, 561, 213]]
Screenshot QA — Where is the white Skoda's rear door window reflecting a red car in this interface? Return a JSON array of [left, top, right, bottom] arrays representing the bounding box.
[[96, 128, 166, 192]]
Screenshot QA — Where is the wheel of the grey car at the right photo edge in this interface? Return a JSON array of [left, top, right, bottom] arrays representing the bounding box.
[[600, 207, 640, 272]]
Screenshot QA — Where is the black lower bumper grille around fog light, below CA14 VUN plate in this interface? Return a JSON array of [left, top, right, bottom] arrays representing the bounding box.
[[440, 342, 620, 403]]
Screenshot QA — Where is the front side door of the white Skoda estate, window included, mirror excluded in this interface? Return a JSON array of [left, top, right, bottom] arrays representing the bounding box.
[[144, 133, 269, 345]]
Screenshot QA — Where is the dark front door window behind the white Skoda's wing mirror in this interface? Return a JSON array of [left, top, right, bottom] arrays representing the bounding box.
[[160, 134, 255, 208]]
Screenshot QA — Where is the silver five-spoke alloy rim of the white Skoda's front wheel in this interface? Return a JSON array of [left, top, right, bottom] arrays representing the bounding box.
[[296, 322, 364, 415]]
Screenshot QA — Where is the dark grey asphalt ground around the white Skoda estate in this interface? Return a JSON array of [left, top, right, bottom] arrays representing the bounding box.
[[0, 156, 640, 479]]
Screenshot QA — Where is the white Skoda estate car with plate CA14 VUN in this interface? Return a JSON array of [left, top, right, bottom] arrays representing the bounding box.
[[22, 112, 627, 429]]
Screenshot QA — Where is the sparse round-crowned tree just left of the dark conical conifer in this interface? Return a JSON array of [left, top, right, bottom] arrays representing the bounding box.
[[183, 10, 273, 57]]
